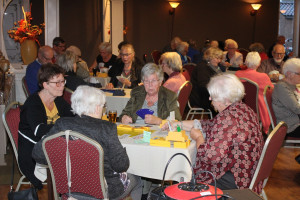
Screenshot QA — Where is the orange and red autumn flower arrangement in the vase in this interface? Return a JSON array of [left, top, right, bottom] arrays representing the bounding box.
[[8, 7, 45, 44]]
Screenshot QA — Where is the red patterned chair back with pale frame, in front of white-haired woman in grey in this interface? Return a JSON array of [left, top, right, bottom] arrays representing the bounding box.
[[42, 130, 107, 200]]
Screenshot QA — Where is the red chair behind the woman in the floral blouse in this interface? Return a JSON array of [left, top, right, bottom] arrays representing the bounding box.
[[249, 121, 287, 200]]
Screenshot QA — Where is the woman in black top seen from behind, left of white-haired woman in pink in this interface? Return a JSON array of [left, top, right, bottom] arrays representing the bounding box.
[[189, 47, 222, 113]]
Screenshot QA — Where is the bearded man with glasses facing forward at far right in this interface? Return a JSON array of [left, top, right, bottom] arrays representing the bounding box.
[[257, 44, 285, 76]]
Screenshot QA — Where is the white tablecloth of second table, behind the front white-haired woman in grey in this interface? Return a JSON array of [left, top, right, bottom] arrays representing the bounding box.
[[105, 89, 131, 117]]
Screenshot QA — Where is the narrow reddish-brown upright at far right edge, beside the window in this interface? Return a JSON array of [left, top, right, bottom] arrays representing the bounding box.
[[293, 0, 300, 57]]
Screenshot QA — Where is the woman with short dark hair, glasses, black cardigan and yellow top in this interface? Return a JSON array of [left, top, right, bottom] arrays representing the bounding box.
[[18, 63, 73, 189]]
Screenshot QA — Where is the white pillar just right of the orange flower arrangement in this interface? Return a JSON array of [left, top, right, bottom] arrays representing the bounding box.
[[44, 0, 59, 47]]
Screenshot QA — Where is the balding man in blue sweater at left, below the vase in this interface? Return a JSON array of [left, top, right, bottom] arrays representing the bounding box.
[[25, 46, 54, 94]]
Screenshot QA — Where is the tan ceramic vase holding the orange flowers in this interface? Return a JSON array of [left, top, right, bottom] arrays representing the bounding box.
[[21, 40, 37, 65]]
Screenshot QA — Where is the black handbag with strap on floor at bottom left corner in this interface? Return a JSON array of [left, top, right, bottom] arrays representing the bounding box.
[[7, 154, 39, 200]]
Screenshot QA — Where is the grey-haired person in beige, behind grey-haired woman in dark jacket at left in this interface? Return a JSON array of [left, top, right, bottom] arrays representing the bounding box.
[[66, 45, 90, 79]]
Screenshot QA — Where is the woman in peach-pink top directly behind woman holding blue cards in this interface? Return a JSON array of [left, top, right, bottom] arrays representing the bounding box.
[[159, 52, 186, 94]]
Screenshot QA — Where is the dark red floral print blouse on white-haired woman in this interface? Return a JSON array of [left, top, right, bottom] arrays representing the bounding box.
[[194, 102, 264, 192]]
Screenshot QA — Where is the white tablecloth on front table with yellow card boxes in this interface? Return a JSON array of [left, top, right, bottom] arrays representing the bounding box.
[[120, 127, 196, 181]]
